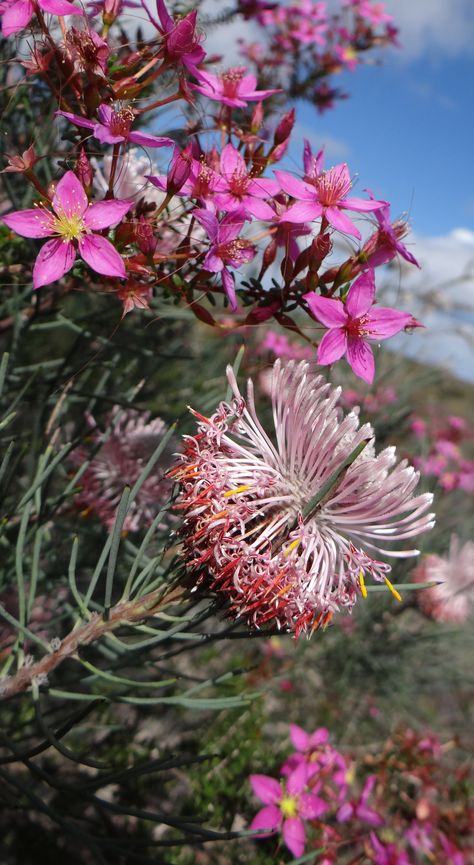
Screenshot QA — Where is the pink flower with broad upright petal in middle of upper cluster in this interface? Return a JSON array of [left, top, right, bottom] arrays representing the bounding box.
[[214, 144, 279, 219]]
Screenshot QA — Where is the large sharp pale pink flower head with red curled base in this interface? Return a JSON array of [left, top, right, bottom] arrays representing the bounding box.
[[172, 360, 433, 635]]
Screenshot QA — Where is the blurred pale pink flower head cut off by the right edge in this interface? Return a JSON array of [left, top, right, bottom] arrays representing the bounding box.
[[413, 535, 474, 623]]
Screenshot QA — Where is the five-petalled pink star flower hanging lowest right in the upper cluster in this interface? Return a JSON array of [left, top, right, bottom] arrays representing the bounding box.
[[303, 270, 413, 384]]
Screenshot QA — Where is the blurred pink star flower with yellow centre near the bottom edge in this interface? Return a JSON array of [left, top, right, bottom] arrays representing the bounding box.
[[249, 763, 328, 856]]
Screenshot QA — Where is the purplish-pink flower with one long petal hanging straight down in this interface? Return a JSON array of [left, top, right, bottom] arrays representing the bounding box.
[[193, 209, 255, 311]]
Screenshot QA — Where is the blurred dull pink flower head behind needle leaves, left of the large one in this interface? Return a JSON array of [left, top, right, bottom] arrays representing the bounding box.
[[70, 406, 170, 532]]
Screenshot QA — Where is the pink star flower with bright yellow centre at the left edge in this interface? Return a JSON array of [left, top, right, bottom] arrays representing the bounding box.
[[2, 171, 132, 288]]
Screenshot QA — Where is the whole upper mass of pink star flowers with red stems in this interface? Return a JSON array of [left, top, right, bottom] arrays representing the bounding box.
[[0, 0, 417, 382]]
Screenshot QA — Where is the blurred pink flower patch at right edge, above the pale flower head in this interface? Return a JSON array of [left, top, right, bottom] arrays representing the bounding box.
[[411, 412, 474, 494]]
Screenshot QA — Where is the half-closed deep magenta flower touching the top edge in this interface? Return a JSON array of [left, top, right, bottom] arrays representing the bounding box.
[[142, 0, 206, 73]]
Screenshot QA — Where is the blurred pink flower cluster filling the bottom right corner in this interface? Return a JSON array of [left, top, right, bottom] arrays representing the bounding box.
[[249, 724, 474, 865]]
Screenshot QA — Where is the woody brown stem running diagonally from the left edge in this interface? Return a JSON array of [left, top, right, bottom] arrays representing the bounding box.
[[0, 585, 187, 698]]
